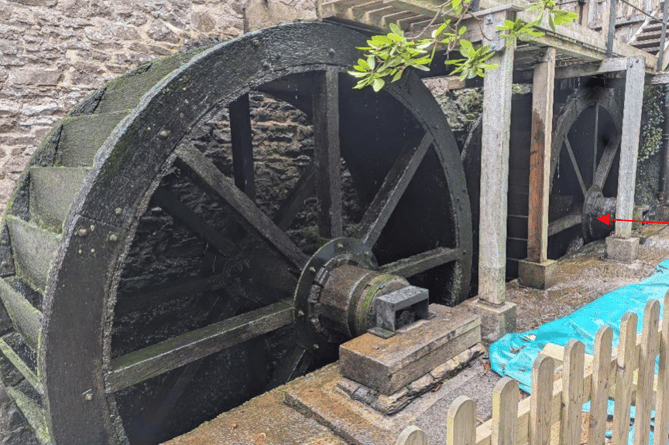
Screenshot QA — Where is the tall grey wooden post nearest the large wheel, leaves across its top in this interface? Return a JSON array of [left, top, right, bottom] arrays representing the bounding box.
[[479, 11, 514, 305]]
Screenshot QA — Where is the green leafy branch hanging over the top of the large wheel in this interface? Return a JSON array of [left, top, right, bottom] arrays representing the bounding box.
[[349, 0, 578, 91]]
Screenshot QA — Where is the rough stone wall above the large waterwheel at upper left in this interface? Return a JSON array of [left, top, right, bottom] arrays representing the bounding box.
[[0, 0, 315, 211]]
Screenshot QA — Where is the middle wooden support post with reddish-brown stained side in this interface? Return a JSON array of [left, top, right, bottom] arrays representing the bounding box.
[[527, 48, 556, 263]]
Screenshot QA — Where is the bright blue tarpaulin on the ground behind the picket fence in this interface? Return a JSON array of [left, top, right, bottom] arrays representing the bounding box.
[[490, 260, 669, 440]]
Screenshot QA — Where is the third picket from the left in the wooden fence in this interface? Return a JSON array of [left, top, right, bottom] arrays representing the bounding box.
[[492, 377, 520, 445]]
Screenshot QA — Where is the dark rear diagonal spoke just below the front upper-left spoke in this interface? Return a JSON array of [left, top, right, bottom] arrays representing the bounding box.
[[153, 187, 235, 256]]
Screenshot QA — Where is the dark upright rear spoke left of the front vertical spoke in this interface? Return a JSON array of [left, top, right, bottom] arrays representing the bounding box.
[[228, 94, 256, 201]]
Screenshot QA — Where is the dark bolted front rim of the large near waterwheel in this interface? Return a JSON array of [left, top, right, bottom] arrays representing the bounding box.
[[0, 24, 471, 444]]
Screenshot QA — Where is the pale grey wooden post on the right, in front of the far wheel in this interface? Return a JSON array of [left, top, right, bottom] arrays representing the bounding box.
[[615, 56, 645, 238]]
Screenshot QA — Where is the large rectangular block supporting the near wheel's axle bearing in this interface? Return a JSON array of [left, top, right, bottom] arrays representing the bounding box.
[[339, 304, 481, 395]]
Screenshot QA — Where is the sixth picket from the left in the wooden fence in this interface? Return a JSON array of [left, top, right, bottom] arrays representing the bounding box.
[[588, 326, 613, 445]]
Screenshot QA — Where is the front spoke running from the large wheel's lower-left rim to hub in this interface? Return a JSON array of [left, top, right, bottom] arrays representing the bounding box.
[[107, 298, 294, 393]]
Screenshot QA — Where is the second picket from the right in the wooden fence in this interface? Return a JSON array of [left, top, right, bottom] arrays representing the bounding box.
[[634, 300, 660, 445]]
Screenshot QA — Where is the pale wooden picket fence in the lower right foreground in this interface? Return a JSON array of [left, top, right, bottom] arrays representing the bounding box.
[[395, 291, 669, 445]]
